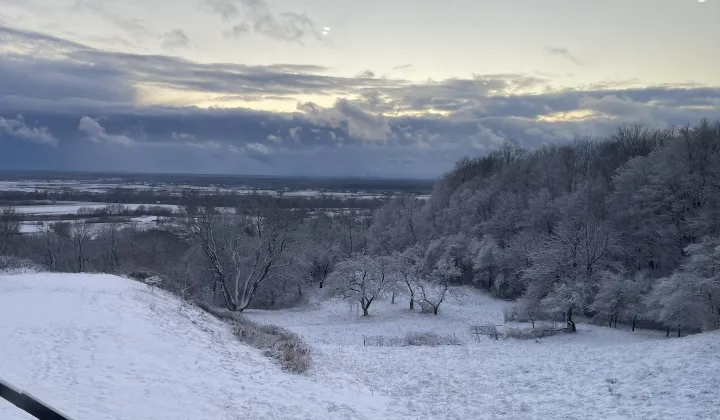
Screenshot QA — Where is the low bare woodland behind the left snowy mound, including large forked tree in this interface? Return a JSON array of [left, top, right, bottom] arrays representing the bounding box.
[[0, 195, 370, 311]]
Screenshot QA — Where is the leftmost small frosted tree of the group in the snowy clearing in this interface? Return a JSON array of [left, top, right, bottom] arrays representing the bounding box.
[[328, 254, 395, 316]]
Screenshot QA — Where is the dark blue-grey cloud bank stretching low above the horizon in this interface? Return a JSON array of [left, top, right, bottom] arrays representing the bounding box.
[[0, 25, 720, 177]]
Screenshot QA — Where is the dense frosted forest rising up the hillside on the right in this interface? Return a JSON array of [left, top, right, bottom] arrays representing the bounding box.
[[370, 121, 720, 331]]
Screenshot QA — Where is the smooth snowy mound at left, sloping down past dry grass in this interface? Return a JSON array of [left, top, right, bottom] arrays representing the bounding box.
[[0, 274, 388, 420]]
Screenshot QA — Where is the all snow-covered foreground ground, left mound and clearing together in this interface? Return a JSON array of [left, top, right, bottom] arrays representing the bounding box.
[[0, 274, 720, 420]]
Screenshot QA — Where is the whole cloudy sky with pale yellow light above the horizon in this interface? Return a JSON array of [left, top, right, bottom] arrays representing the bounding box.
[[0, 0, 720, 178]]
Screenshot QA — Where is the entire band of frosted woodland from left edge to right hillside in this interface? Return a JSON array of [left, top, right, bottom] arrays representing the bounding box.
[[0, 121, 720, 332]]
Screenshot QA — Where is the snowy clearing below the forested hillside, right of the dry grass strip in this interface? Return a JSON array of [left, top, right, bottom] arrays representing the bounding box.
[[250, 293, 720, 420]]
